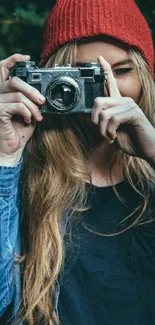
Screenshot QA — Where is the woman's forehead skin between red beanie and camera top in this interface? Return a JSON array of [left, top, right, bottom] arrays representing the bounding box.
[[76, 41, 129, 65]]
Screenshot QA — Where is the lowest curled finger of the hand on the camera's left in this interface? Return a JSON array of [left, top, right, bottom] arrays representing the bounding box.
[[0, 103, 32, 125]]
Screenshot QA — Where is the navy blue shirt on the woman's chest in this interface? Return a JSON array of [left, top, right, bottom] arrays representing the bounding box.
[[58, 182, 155, 325]]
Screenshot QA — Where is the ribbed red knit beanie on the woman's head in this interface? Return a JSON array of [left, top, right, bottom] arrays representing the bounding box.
[[41, 0, 154, 72]]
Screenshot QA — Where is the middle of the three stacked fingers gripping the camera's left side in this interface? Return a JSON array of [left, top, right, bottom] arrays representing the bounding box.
[[0, 92, 43, 122]]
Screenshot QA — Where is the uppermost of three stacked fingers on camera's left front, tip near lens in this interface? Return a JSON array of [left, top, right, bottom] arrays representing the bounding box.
[[0, 77, 46, 105]]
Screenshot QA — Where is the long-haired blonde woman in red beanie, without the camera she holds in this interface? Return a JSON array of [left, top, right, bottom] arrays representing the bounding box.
[[0, 0, 155, 325]]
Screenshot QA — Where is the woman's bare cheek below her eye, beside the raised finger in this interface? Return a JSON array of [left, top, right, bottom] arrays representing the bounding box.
[[117, 77, 141, 103]]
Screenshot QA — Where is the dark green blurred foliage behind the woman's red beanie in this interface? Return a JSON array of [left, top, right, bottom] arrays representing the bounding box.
[[0, 0, 155, 62]]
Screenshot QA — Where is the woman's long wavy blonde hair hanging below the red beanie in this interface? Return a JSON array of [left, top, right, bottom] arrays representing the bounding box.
[[17, 38, 155, 325]]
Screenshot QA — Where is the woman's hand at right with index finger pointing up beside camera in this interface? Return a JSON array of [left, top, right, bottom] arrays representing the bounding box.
[[91, 56, 155, 163]]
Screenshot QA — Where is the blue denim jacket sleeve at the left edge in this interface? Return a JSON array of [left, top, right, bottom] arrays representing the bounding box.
[[0, 163, 21, 316]]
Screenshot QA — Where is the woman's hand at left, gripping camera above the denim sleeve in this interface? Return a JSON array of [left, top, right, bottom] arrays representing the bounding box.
[[0, 54, 45, 166]]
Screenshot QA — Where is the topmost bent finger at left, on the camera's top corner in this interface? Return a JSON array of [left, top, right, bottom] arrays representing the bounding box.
[[0, 54, 30, 83]]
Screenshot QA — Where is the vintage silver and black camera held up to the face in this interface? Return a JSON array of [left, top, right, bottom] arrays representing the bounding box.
[[12, 61, 107, 114]]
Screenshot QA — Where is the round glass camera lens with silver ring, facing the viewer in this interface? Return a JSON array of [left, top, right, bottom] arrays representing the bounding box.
[[46, 77, 80, 113]]
